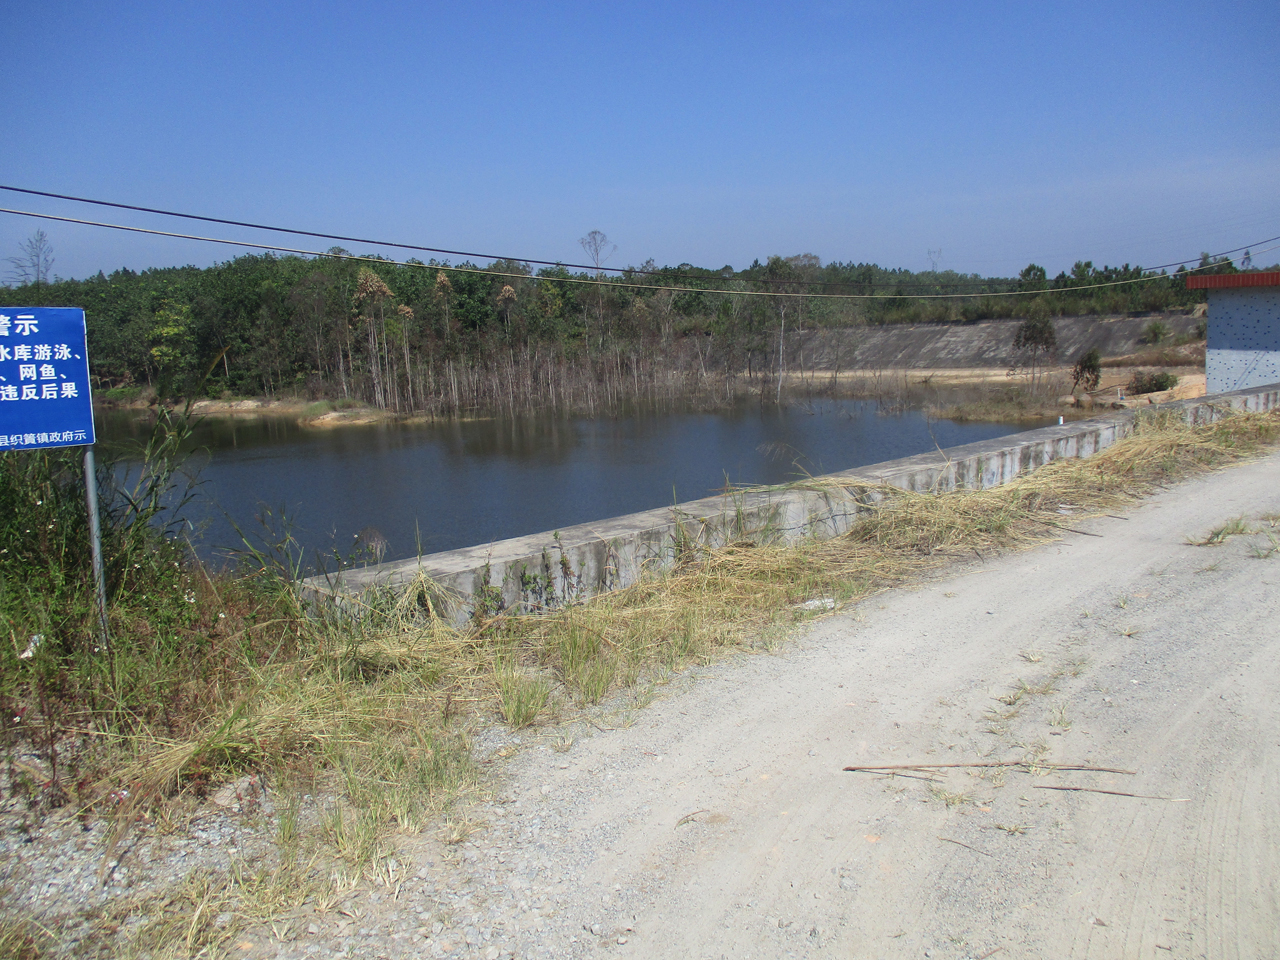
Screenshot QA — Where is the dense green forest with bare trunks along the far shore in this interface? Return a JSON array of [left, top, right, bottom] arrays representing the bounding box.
[[0, 234, 1235, 416]]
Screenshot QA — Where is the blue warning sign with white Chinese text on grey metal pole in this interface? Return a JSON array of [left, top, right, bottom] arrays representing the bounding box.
[[0, 307, 110, 650]]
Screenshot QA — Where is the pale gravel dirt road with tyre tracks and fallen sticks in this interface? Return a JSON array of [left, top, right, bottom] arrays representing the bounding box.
[[293, 456, 1280, 960]]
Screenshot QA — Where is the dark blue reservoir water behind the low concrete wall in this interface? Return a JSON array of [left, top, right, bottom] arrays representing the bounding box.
[[99, 401, 1025, 576]]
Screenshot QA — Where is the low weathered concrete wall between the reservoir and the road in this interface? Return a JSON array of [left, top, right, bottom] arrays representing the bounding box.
[[303, 384, 1280, 623]]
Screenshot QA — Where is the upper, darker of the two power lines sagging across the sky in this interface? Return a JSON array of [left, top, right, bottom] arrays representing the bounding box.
[[0, 184, 1280, 298]]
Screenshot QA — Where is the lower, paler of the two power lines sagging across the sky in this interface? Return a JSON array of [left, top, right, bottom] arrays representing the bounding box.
[[0, 207, 1280, 300]]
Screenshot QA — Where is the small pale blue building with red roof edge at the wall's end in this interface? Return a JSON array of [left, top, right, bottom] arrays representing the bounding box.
[[1187, 273, 1280, 393]]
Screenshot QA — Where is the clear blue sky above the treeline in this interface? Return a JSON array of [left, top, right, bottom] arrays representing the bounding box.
[[0, 0, 1280, 276]]
